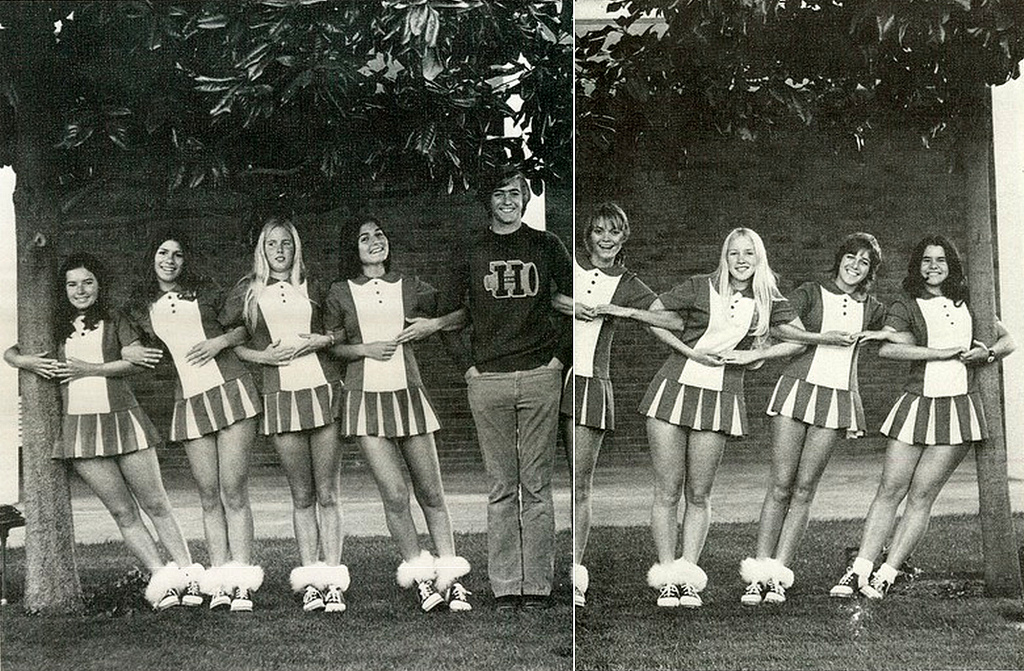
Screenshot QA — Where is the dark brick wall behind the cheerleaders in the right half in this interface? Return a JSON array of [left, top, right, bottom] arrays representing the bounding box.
[[577, 128, 965, 462]]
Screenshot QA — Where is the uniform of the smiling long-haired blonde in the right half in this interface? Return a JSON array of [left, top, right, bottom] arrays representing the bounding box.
[[639, 275, 796, 435]]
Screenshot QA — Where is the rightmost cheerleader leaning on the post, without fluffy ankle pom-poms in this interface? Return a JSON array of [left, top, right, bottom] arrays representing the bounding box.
[[830, 236, 1016, 599]]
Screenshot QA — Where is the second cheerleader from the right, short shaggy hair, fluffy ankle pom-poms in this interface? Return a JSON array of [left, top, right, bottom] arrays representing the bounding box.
[[740, 233, 889, 605]]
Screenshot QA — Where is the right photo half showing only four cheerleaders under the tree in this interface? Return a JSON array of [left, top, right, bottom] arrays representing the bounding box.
[[573, 0, 1024, 670]]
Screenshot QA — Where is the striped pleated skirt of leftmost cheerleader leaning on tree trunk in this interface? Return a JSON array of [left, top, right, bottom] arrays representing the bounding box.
[[52, 406, 162, 459]]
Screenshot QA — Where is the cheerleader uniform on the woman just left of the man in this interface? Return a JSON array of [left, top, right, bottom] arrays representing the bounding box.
[[324, 272, 440, 438]]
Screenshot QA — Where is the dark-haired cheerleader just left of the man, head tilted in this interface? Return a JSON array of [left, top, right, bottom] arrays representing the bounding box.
[[325, 219, 472, 613]]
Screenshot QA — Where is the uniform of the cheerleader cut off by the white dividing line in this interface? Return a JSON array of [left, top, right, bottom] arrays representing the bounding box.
[[562, 254, 657, 431]]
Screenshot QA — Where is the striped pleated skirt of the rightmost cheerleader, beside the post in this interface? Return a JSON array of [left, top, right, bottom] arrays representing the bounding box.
[[880, 391, 988, 445]]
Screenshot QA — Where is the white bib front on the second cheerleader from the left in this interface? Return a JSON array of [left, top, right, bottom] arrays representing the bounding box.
[[150, 291, 224, 399]]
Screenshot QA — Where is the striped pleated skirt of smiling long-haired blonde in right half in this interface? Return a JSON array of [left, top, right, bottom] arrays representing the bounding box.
[[638, 375, 746, 435]]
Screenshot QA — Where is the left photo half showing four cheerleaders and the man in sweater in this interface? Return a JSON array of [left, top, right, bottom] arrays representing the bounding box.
[[0, 0, 573, 670]]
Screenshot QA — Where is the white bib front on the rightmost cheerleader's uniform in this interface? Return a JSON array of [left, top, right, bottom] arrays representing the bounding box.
[[916, 296, 974, 396]]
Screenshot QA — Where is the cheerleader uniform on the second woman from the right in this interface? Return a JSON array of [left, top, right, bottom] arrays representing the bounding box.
[[767, 280, 885, 437]]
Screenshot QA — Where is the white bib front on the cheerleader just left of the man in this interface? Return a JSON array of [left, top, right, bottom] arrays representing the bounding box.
[[348, 278, 409, 391]]
